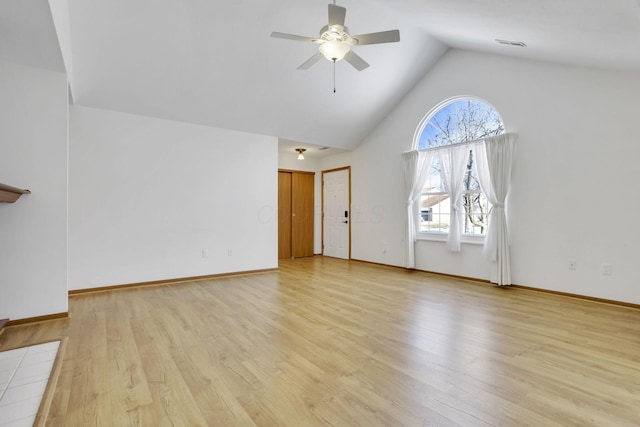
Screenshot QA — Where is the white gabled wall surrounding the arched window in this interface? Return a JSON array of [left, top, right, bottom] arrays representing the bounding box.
[[351, 50, 640, 303]]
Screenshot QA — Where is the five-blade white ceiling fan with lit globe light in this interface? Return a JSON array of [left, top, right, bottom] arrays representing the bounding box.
[[271, 1, 400, 71]]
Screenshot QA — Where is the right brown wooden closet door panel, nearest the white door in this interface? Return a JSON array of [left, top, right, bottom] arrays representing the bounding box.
[[291, 173, 314, 258]]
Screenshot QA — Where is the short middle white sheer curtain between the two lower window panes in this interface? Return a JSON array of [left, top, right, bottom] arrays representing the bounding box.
[[438, 145, 470, 252]]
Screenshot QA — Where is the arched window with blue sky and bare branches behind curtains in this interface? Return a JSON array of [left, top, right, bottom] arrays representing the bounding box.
[[414, 97, 505, 236]]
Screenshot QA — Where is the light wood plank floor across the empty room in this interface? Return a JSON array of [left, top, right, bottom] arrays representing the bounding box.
[[0, 257, 640, 427]]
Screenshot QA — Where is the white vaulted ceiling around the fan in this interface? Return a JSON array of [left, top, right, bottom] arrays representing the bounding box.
[[0, 0, 640, 154]]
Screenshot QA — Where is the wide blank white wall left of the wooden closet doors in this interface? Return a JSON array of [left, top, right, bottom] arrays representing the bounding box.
[[69, 106, 278, 289]]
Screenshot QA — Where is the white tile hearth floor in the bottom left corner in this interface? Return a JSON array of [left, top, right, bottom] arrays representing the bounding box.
[[0, 341, 60, 427]]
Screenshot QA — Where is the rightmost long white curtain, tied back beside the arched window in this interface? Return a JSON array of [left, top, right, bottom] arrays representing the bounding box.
[[475, 133, 518, 286]]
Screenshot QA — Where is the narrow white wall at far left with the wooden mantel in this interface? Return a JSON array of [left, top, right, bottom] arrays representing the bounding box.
[[0, 62, 67, 319]]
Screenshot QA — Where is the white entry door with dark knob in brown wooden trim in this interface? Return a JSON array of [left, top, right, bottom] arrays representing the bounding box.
[[322, 169, 351, 259]]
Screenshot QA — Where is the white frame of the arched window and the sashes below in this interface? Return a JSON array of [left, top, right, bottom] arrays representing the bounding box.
[[413, 95, 505, 243]]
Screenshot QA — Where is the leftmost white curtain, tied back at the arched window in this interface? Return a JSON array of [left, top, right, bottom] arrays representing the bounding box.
[[402, 150, 434, 268]]
